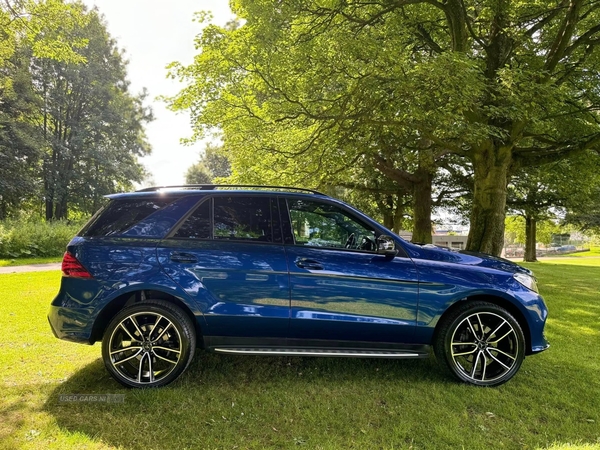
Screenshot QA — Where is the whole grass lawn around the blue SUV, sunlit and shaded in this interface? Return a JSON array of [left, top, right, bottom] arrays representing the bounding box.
[[0, 258, 600, 450]]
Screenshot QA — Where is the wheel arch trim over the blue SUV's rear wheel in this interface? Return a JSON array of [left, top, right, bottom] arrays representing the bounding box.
[[90, 289, 202, 346]]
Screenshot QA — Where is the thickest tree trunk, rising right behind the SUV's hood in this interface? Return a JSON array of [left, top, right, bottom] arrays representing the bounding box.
[[467, 142, 512, 256]]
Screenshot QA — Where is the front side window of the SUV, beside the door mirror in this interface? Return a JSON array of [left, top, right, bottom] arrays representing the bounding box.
[[288, 199, 377, 251]]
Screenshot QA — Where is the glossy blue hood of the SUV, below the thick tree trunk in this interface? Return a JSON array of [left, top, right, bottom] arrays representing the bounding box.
[[406, 243, 532, 275]]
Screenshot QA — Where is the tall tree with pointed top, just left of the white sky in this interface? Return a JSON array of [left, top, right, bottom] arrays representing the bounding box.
[[32, 6, 152, 220]]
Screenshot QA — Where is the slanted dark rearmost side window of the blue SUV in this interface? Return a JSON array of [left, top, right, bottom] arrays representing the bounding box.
[[79, 198, 173, 237]]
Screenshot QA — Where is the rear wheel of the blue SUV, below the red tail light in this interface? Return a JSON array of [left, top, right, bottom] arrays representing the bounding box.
[[102, 300, 196, 388]]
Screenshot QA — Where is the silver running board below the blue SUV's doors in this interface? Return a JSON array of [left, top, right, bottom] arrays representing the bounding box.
[[212, 347, 429, 358]]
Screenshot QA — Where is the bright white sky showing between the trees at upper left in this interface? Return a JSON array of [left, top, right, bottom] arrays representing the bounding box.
[[84, 0, 232, 187]]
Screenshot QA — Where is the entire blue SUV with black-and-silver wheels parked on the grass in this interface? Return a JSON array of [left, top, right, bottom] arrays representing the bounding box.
[[48, 185, 548, 387]]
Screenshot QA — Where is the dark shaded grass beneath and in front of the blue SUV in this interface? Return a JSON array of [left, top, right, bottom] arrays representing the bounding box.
[[44, 352, 600, 449]]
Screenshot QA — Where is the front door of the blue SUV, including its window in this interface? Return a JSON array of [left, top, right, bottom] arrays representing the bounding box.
[[282, 197, 418, 345]]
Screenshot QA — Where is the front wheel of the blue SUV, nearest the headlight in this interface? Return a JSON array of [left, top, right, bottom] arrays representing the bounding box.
[[434, 301, 525, 386]]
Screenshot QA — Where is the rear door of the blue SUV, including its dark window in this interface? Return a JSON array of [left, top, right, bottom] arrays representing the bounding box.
[[158, 194, 290, 342]]
